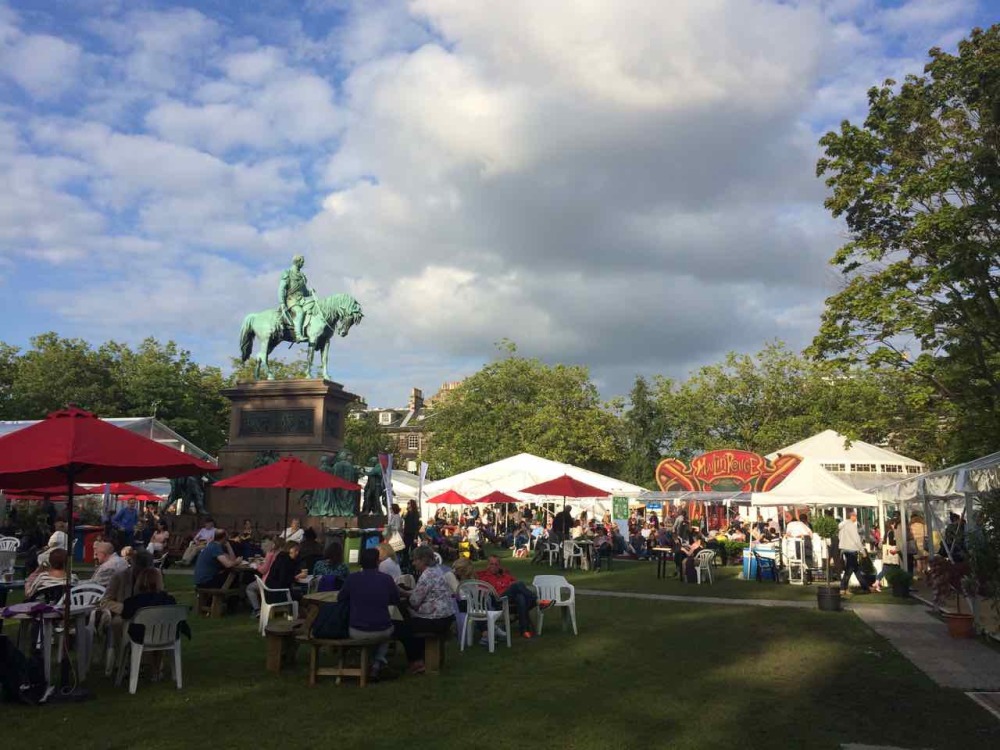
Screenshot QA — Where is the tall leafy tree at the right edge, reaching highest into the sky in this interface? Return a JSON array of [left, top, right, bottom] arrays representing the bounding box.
[[814, 26, 1000, 460]]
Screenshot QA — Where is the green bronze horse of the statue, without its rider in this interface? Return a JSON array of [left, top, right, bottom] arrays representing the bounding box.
[[240, 294, 364, 380]]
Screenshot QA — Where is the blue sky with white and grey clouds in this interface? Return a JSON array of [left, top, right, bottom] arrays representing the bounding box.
[[0, 0, 1000, 406]]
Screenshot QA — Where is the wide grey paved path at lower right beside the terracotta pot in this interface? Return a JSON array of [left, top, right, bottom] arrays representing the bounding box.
[[854, 604, 1000, 690]]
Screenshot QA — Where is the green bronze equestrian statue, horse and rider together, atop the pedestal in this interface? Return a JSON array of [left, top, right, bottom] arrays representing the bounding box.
[[240, 255, 364, 380]]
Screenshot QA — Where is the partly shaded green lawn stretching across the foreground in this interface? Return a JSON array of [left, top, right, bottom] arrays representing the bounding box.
[[0, 561, 1000, 750]]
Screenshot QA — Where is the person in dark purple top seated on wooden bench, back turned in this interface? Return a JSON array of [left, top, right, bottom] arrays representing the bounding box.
[[337, 549, 398, 681]]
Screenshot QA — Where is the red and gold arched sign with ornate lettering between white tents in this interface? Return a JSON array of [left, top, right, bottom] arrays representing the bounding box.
[[656, 450, 802, 492]]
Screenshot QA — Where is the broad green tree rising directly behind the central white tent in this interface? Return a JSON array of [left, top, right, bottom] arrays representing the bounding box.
[[427, 345, 620, 477]]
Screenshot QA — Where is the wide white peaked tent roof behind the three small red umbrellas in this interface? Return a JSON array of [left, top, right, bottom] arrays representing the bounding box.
[[424, 453, 646, 506]]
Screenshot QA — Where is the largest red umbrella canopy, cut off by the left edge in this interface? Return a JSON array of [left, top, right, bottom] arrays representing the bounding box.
[[0, 407, 219, 488]]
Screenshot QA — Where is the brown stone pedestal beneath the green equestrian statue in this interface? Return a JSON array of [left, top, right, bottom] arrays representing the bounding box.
[[207, 379, 358, 532]]
